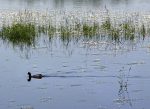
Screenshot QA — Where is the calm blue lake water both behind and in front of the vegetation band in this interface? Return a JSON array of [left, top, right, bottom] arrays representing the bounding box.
[[0, 0, 150, 109]]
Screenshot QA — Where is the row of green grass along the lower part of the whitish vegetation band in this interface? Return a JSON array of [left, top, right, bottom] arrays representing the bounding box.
[[0, 21, 146, 46]]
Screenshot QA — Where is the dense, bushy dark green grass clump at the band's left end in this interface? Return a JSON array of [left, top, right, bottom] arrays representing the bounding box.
[[0, 23, 37, 46]]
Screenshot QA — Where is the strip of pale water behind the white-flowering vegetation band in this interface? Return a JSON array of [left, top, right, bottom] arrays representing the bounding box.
[[0, 0, 150, 11]]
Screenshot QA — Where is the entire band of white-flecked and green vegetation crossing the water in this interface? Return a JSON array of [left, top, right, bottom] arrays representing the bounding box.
[[0, 10, 150, 46]]
